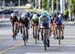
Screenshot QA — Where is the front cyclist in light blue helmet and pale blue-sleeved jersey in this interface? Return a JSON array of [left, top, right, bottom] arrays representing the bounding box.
[[39, 11, 50, 46]]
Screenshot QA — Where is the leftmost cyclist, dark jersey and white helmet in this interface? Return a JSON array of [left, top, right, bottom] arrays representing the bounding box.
[[10, 13, 18, 38]]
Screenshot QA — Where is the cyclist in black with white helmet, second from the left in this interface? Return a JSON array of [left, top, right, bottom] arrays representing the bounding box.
[[19, 13, 30, 40]]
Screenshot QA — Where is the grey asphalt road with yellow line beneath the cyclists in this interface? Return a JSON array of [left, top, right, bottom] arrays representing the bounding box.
[[0, 21, 75, 54]]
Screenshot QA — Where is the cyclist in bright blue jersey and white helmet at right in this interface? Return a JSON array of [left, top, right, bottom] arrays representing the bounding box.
[[56, 14, 64, 39]]
